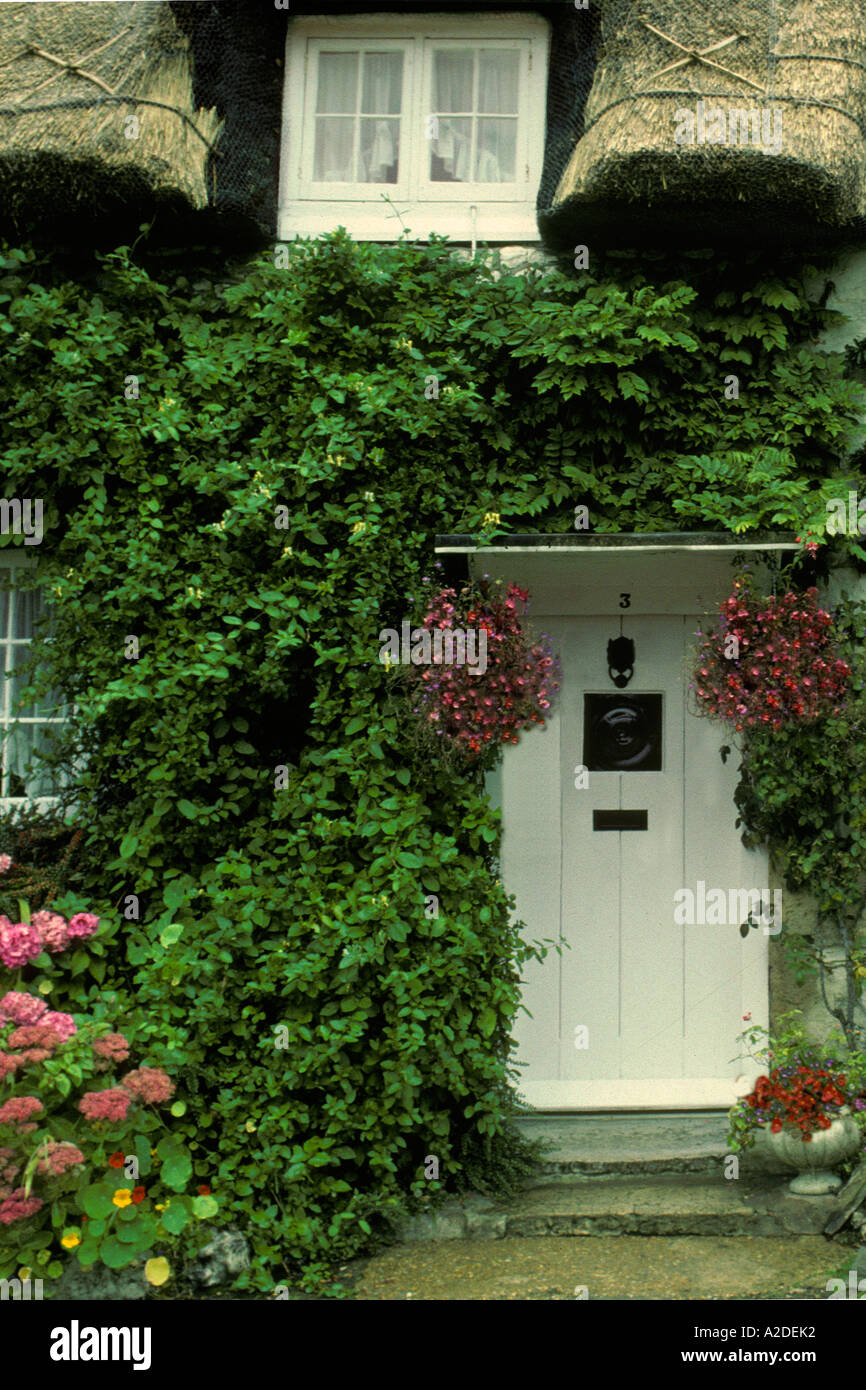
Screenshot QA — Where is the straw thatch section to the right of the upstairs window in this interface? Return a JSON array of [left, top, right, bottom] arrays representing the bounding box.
[[552, 0, 866, 227]]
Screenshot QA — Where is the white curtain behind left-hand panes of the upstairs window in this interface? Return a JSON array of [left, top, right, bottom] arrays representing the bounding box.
[[313, 51, 403, 183]]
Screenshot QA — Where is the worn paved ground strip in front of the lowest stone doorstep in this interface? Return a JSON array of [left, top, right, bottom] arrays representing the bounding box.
[[342, 1236, 853, 1302]]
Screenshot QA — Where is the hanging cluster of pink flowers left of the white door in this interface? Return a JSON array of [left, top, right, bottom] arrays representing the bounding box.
[[417, 577, 559, 758]]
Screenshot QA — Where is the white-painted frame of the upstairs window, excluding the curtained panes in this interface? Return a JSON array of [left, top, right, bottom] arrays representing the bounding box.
[[278, 11, 550, 243]]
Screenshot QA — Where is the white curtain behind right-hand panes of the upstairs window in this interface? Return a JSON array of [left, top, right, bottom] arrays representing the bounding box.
[[431, 49, 518, 183]]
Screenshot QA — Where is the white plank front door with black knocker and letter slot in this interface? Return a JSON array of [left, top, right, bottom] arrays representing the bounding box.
[[502, 612, 774, 1109]]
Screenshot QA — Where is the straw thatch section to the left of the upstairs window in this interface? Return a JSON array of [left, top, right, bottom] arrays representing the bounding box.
[[0, 3, 220, 222]]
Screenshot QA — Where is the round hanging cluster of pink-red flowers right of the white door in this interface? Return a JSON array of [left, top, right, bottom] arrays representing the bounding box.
[[691, 580, 851, 730]]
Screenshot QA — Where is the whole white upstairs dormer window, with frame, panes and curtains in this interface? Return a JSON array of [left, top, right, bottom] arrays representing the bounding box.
[[279, 14, 548, 240]]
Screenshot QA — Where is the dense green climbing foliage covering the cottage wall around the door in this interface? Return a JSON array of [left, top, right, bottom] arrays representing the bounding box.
[[0, 234, 858, 1287]]
